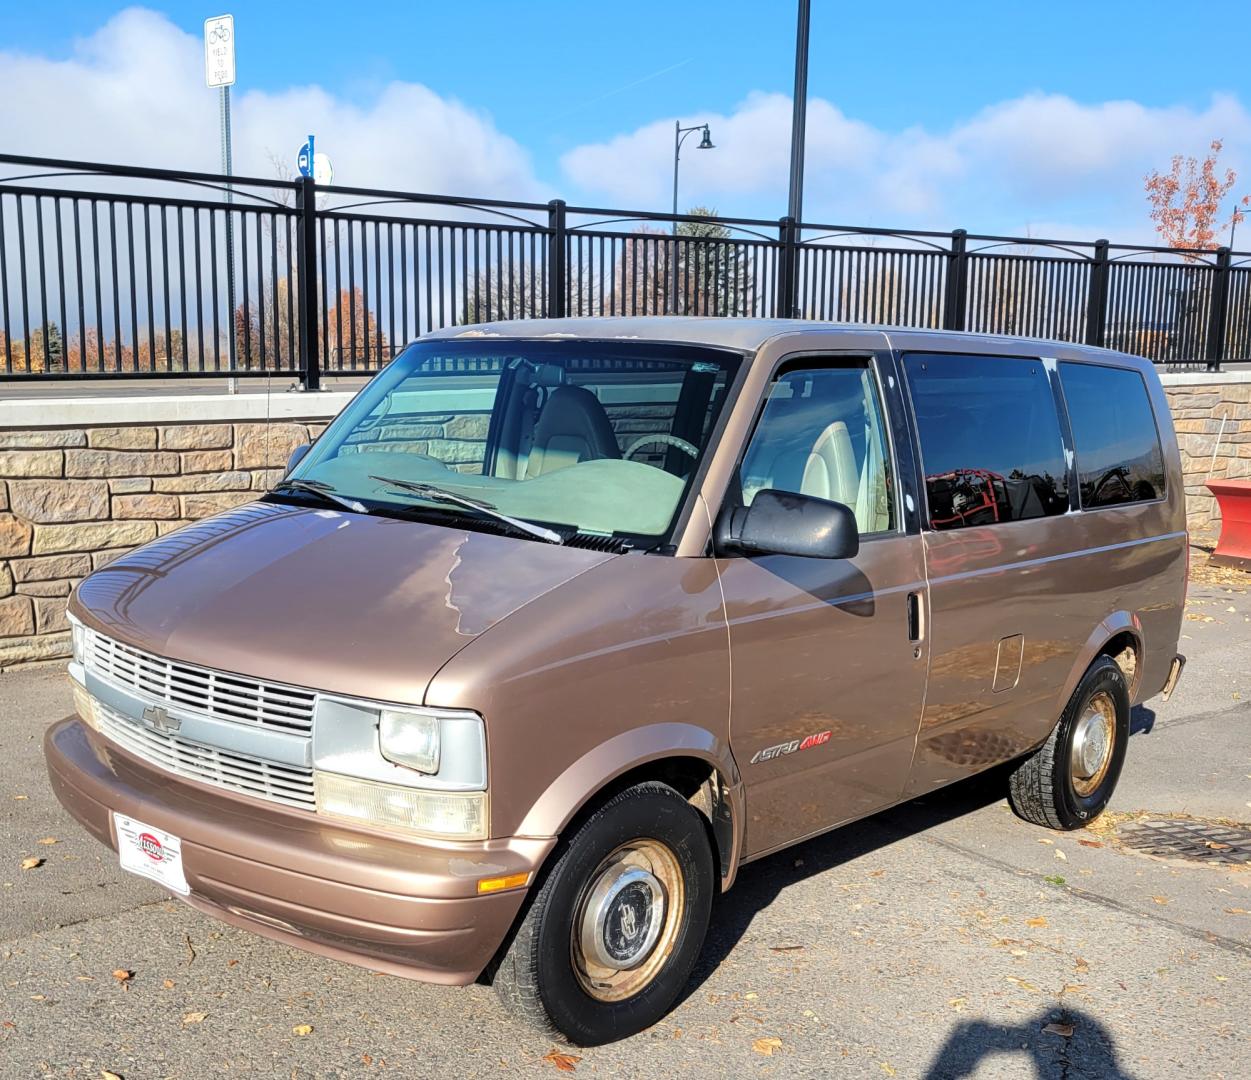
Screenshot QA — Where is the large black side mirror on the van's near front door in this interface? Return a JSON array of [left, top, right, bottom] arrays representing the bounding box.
[[717, 488, 859, 558]]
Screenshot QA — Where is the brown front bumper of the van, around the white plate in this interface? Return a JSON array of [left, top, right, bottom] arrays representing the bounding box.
[[44, 717, 555, 985]]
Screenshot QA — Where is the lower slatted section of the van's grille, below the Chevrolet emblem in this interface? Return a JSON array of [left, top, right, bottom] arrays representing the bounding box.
[[93, 700, 315, 810]]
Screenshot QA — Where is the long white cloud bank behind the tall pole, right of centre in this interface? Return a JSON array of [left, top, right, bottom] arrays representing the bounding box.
[[562, 94, 1251, 240]]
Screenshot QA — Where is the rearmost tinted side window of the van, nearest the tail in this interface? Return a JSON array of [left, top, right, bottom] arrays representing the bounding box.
[[1060, 363, 1165, 509]]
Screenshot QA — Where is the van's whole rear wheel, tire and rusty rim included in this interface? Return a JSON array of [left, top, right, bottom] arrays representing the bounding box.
[[1008, 656, 1130, 830]]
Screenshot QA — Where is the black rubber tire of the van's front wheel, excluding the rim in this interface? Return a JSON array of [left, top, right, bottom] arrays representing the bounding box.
[[494, 782, 717, 1046]]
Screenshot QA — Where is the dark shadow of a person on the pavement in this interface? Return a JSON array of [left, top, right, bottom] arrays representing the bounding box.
[[921, 1007, 1133, 1080]]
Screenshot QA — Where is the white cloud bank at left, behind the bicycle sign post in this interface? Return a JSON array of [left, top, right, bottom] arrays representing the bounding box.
[[0, 8, 549, 199]]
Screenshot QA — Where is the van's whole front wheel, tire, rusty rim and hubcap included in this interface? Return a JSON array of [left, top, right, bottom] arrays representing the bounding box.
[[494, 782, 716, 1046]]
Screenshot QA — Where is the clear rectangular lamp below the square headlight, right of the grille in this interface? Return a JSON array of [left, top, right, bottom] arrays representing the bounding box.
[[314, 772, 488, 840]]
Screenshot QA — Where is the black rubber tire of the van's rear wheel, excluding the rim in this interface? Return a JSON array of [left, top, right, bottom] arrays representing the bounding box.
[[1008, 656, 1130, 831]]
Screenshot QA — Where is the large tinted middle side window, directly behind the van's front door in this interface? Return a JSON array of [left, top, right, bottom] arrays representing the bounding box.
[[903, 353, 1068, 529]]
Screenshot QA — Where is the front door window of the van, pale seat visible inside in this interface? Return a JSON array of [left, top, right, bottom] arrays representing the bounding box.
[[739, 364, 896, 536]]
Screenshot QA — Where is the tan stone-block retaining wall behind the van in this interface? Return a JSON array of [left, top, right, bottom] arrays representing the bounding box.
[[0, 373, 1251, 671]]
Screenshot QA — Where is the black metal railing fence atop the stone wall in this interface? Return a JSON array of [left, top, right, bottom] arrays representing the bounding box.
[[0, 155, 1251, 388]]
